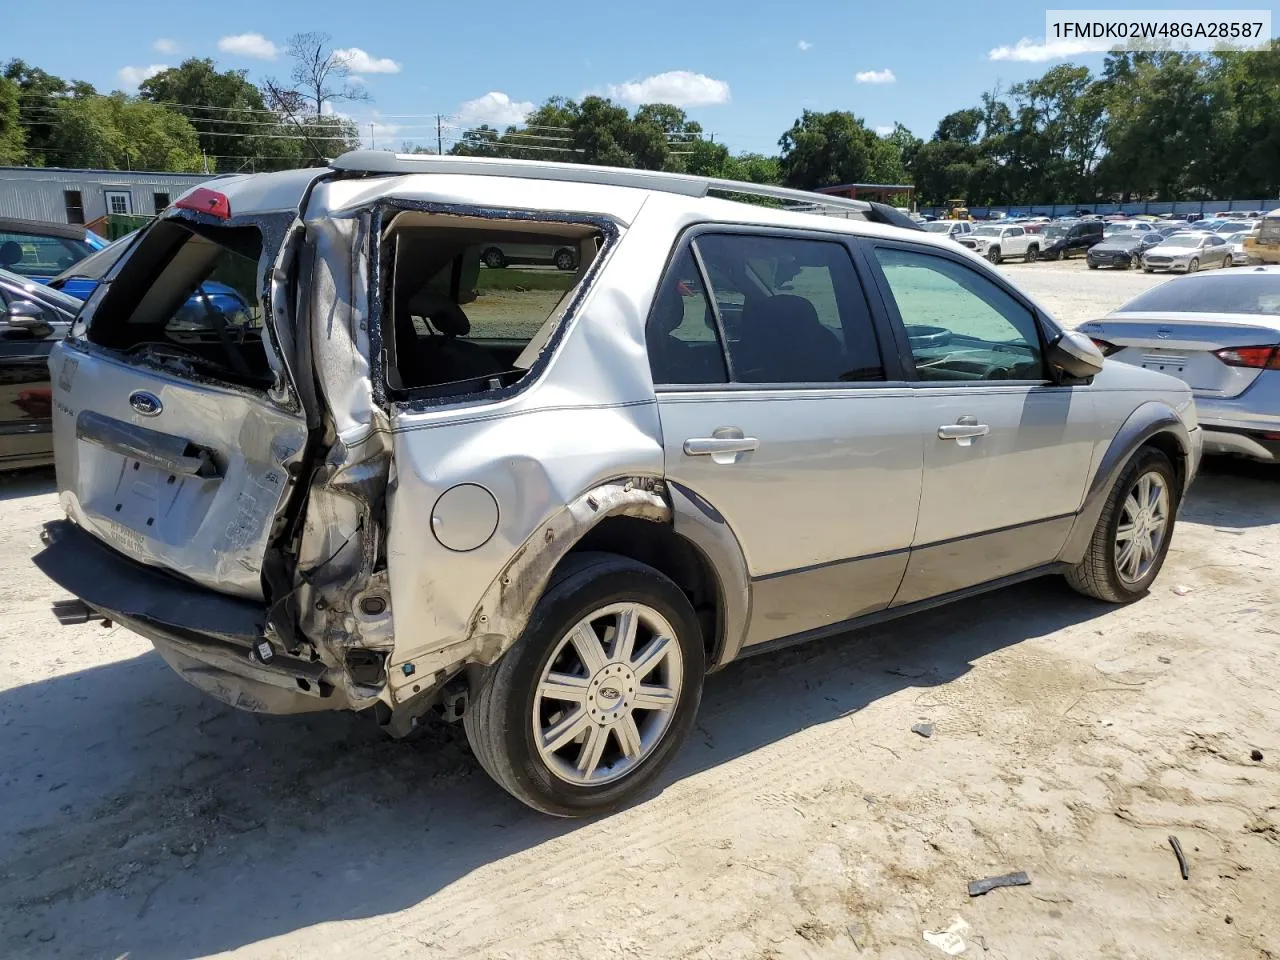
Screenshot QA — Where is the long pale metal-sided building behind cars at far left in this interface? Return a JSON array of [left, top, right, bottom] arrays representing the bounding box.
[[0, 166, 210, 223]]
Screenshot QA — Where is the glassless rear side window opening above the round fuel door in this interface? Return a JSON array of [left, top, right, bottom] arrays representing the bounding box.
[[380, 211, 603, 398]]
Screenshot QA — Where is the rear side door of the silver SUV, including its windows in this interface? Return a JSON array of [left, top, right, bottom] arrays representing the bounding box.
[[648, 232, 923, 644]]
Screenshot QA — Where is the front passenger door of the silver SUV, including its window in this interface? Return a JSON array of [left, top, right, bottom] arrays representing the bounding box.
[[868, 242, 1093, 605]]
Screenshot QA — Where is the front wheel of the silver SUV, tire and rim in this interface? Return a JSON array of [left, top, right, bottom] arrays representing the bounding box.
[[1066, 447, 1179, 603]]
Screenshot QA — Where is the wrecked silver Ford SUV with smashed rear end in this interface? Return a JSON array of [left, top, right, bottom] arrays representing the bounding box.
[[36, 154, 1201, 815]]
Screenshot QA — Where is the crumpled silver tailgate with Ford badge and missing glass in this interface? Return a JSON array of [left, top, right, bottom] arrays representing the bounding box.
[[50, 212, 307, 599]]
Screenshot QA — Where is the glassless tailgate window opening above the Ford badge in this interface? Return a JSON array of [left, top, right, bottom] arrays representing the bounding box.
[[86, 220, 274, 389]]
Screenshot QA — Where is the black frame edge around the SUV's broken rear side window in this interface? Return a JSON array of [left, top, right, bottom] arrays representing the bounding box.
[[367, 197, 621, 412]]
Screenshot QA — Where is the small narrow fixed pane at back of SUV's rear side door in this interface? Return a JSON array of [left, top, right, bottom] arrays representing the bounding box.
[[645, 247, 741, 384]]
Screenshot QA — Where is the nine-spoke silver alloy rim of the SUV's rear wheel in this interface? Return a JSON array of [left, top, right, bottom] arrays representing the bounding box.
[[531, 603, 684, 787]]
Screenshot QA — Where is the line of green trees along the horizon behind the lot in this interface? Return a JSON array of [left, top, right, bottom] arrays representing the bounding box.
[[0, 44, 1280, 205]]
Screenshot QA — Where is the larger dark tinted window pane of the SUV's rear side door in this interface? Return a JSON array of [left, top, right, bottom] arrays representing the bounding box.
[[696, 234, 884, 383]]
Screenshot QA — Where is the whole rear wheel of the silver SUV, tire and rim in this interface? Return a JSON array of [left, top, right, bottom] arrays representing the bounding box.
[[463, 553, 705, 817]]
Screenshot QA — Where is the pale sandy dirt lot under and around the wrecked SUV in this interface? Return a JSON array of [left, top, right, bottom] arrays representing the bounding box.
[[0, 262, 1280, 960]]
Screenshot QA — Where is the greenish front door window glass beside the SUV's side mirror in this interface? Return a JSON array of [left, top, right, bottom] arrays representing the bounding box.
[[876, 247, 1044, 381]]
